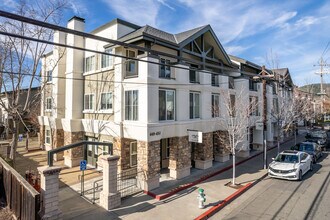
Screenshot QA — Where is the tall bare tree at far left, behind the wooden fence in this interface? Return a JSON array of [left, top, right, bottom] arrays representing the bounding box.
[[0, 0, 67, 164]]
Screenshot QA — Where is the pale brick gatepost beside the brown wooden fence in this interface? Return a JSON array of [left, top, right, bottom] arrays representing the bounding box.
[[38, 166, 62, 219]]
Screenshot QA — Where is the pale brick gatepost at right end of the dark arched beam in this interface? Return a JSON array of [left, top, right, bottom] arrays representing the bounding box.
[[99, 155, 121, 210]]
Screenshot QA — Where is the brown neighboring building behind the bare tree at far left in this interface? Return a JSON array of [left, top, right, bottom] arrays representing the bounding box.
[[0, 87, 40, 138]]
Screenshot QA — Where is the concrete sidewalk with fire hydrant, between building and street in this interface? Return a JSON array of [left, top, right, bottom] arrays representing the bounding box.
[[60, 132, 304, 220]]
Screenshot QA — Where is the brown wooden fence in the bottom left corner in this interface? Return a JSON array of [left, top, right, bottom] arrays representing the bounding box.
[[0, 157, 40, 220]]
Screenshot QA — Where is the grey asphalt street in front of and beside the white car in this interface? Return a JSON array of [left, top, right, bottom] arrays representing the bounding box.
[[212, 152, 330, 219]]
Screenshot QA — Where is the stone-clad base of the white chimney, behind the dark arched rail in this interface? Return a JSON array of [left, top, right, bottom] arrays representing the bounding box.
[[63, 131, 84, 167]]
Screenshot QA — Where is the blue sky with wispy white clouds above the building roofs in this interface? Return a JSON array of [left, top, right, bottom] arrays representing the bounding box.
[[0, 0, 330, 86]]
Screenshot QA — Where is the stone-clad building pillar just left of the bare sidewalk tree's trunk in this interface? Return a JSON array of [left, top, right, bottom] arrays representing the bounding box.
[[213, 131, 230, 162]]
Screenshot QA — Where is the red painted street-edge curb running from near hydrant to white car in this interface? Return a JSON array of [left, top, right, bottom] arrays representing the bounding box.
[[195, 174, 268, 220]]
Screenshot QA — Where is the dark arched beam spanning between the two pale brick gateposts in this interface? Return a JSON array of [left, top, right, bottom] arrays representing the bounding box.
[[48, 141, 113, 167]]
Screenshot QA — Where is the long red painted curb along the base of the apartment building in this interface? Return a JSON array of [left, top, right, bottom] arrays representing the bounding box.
[[143, 139, 291, 201]]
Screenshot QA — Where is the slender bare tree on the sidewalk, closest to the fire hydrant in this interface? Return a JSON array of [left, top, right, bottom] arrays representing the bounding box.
[[220, 88, 258, 185]]
